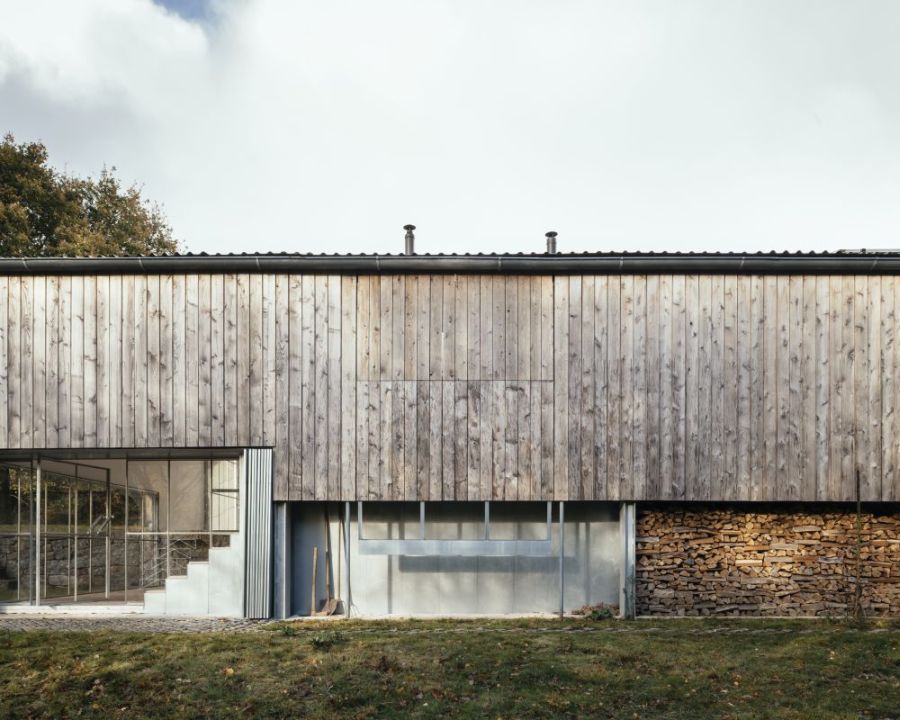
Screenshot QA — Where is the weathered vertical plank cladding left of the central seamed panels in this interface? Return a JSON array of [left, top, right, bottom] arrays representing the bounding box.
[[0, 274, 344, 499]]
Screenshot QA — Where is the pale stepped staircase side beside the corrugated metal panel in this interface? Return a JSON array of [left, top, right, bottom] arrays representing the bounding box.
[[144, 535, 244, 617]]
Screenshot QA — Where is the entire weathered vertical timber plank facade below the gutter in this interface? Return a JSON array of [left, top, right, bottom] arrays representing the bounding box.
[[0, 272, 900, 501]]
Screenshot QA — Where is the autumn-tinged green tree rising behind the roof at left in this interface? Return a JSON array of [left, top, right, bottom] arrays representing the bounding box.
[[0, 135, 178, 257]]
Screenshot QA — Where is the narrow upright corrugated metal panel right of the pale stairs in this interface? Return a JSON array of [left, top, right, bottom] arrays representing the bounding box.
[[244, 449, 272, 618]]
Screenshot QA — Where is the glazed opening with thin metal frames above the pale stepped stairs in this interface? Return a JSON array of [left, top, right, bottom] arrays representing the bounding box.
[[0, 458, 240, 605]]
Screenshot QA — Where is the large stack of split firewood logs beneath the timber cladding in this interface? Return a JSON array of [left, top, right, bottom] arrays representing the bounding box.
[[636, 505, 900, 617]]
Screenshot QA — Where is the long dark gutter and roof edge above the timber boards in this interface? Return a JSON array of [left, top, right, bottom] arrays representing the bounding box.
[[0, 253, 900, 275]]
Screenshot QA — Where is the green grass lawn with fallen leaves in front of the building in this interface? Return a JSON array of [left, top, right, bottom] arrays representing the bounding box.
[[0, 619, 900, 720]]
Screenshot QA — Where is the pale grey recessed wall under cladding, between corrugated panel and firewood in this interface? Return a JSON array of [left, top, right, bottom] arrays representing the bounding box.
[[290, 503, 622, 616]]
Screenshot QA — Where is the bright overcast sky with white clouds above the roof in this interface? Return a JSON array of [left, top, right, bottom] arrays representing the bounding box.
[[0, 0, 900, 252]]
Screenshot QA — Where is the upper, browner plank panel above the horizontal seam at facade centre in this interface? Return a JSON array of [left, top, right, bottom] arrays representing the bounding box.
[[356, 275, 553, 382]]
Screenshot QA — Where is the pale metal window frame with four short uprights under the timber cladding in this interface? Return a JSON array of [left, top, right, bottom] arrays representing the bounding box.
[[356, 500, 553, 557]]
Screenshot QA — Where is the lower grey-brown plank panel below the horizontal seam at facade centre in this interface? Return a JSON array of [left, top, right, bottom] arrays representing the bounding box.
[[355, 380, 553, 501]]
